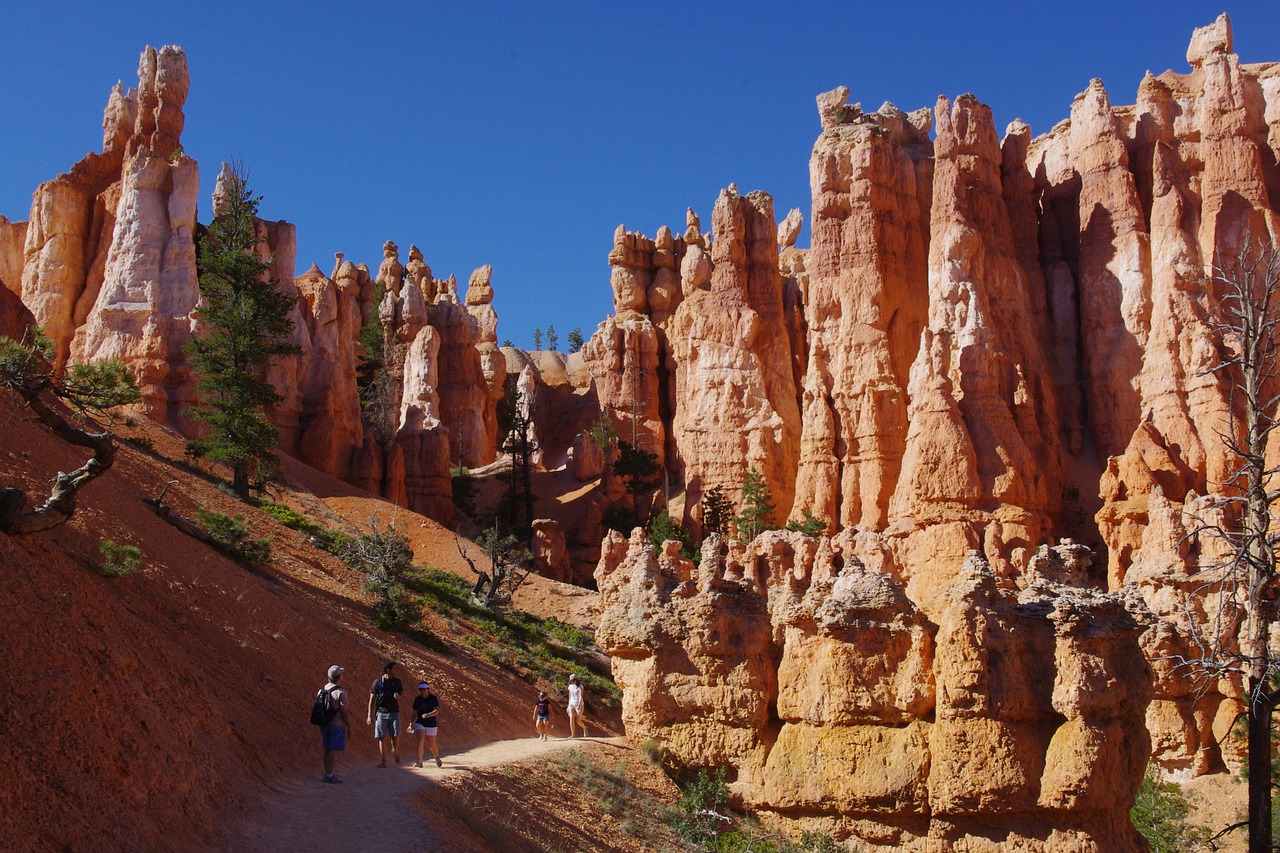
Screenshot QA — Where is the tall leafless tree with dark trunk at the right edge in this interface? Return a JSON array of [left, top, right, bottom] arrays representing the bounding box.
[[1183, 234, 1280, 853]]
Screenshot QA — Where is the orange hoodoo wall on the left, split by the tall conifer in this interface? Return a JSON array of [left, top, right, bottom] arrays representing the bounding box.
[[0, 46, 504, 523]]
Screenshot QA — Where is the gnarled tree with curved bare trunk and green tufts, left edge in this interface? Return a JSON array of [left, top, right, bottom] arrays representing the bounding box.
[[0, 330, 140, 535]]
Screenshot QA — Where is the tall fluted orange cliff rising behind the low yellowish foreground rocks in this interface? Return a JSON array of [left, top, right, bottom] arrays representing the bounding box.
[[576, 9, 1280, 774]]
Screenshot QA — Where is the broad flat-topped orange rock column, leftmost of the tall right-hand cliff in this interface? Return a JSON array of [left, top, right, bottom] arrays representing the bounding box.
[[796, 94, 933, 528]]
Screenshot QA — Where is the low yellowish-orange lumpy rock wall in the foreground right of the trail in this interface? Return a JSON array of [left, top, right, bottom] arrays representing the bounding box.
[[595, 530, 1151, 853]]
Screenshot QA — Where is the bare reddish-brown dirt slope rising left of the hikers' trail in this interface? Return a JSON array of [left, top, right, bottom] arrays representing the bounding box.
[[0, 401, 618, 850]]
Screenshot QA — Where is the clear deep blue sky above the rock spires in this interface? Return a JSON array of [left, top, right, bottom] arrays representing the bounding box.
[[0, 0, 1280, 348]]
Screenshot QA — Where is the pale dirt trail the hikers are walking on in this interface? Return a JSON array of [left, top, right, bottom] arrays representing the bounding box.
[[234, 738, 625, 853]]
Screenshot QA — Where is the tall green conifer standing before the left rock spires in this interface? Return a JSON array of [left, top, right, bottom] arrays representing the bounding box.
[[187, 169, 298, 500]]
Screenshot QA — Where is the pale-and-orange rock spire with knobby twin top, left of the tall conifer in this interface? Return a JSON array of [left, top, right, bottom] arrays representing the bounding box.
[[22, 47, 200, 423]]
